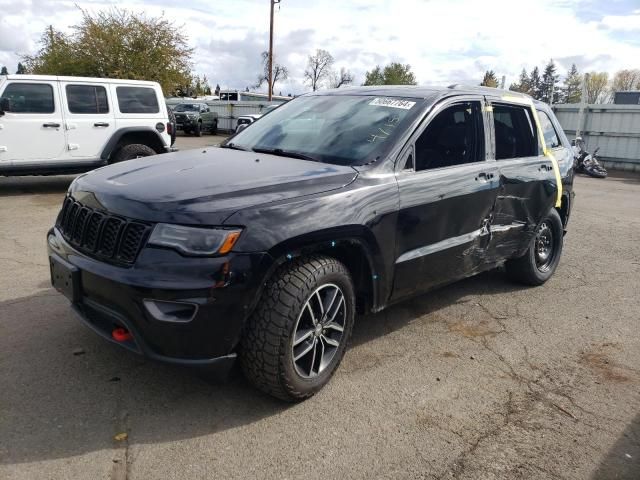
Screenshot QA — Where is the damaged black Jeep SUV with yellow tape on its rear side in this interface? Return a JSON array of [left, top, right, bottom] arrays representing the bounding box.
[[48, 86, 573, 400]]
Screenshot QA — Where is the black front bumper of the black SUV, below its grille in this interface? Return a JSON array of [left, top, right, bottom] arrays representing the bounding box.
[[47, 228, 272, 367]]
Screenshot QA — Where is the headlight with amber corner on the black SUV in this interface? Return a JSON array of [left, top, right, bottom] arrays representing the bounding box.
[[147, 223, 240, 256]]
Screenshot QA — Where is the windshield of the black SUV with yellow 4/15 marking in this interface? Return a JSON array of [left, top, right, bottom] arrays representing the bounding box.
[[223, 95, 424, 165]]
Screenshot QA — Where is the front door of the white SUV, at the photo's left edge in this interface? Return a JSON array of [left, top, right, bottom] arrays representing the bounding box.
[[0, 80, 65, 165]]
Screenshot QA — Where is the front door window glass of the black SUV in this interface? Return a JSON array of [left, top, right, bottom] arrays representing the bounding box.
[[415, 102, 485, 171]]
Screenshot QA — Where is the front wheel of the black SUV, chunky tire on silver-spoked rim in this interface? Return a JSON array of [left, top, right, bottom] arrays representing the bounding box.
[[240, 256, 355, 402]]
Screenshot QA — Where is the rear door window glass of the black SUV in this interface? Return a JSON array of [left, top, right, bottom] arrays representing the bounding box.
[[493, 104, 538, 160]]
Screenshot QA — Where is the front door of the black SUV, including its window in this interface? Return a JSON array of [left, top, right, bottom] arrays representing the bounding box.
[[393, 97, 499, 299]]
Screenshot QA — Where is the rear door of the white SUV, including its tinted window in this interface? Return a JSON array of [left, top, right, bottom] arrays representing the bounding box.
[[60, 82, 116, 160]]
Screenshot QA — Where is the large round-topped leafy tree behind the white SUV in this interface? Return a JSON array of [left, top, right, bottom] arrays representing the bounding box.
[[23, 8, 193, 94]]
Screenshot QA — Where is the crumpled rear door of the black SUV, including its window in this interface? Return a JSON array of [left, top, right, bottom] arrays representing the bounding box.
[[488, 98, 556, 258]]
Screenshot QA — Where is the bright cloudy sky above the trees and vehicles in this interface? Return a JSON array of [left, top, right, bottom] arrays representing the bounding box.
[[0, 0, 640, 94]]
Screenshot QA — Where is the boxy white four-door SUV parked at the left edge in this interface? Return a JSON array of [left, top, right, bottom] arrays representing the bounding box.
[[0, 75, 173, 176]]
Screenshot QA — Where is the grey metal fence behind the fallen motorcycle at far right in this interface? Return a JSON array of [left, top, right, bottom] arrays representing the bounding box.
[[553, 104, 640, 171]]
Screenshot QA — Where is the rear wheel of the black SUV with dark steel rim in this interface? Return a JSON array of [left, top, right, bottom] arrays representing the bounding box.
[[505, 208, 564, 286]]
